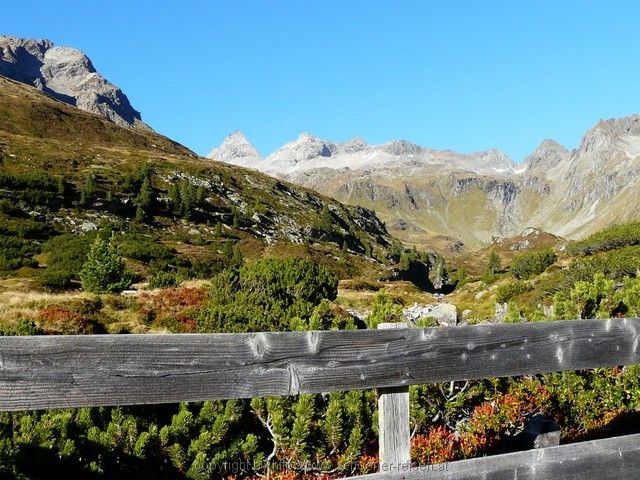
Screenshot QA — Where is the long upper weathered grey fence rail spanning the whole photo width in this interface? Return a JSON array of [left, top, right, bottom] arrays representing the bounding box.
[[0, 318, 640, 410]]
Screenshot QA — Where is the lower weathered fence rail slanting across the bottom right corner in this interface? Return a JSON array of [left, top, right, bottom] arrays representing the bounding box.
[[352, 434, 640, 480]]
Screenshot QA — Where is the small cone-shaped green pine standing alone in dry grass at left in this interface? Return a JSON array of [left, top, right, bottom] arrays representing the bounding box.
[[80, 235, 133, 293]]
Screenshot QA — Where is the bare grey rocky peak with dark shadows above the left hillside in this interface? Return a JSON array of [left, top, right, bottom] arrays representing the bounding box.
[[0, 35, 149, 129]]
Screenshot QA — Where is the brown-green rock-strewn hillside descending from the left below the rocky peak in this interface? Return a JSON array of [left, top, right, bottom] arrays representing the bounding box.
[[0, 77, 391, 284]]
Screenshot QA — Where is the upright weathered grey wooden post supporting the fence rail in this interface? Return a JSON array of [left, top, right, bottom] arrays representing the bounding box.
[[378, 323, 411, 472]]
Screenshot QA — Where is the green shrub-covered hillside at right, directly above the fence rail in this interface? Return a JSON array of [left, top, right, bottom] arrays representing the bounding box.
[[448, 222, 640, 323]]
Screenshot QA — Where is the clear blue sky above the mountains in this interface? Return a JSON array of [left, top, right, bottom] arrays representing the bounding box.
[[0, 0, 640, 161]]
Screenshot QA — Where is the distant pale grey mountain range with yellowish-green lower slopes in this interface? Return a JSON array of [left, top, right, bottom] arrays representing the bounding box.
[[208, 115, 640, 249]]
